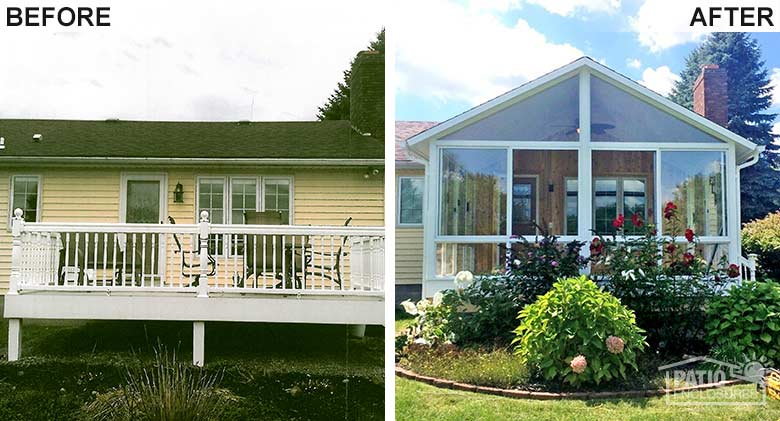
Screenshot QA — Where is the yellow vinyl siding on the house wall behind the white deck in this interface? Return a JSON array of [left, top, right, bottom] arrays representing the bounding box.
[[0, 167, 384, 291]]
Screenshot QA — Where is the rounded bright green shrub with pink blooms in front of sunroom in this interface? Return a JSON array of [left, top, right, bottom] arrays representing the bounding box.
[[513, 276, 645, 386]]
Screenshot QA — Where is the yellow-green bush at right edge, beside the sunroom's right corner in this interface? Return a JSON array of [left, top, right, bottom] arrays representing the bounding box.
[[742, 211, 780, 281]]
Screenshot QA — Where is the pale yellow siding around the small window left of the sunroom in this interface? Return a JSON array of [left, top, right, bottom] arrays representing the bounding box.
[[395, 169, 425, 285]]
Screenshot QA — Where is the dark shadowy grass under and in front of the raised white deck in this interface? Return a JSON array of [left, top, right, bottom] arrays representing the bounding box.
[[0, 304, 384, 420]]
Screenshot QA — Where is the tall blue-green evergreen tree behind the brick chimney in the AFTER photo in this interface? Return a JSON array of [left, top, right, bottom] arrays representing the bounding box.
[[669, 33, 780, 222]]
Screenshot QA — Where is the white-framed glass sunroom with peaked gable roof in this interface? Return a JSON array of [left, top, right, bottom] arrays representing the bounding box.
[[407, 58, 761, 296]]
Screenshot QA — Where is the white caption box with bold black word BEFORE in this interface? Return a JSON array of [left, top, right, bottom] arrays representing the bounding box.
[[0, 5, 111, 28]]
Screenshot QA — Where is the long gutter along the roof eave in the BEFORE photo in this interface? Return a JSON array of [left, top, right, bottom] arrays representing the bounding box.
[[0, 156, 385, 166]]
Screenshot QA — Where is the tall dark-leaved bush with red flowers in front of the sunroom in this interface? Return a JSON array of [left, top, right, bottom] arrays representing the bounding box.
[[590, 202, 739, 355]]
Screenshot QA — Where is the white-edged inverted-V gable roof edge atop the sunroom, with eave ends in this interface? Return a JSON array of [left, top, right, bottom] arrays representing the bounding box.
[[407, 57, 758, 160]]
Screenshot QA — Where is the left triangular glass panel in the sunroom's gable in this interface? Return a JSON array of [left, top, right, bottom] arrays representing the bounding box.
[[443, 76, 580, 142]]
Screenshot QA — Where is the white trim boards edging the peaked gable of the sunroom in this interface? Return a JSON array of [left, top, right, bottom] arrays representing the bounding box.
[[406, 57, 758, 158]]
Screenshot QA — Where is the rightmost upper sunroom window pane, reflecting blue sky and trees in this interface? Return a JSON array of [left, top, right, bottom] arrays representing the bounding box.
[[661, 151, 726, 236]]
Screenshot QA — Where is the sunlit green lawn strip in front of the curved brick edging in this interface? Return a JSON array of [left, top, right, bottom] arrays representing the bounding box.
[[395, 377, 780, 421]]
